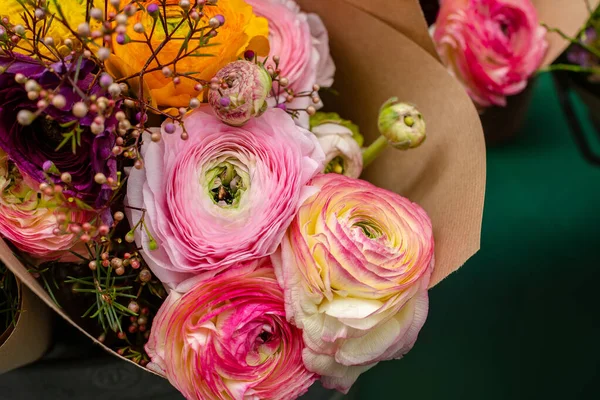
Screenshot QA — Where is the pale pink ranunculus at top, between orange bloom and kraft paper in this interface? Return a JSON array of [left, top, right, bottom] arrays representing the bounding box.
[[246, 0, 335, 128]]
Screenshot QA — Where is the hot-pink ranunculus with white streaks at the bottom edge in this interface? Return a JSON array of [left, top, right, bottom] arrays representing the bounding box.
[[146, 258, 317, 400]]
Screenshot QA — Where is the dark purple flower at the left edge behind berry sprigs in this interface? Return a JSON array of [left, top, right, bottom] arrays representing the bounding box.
[[0, 54, 118, 208]]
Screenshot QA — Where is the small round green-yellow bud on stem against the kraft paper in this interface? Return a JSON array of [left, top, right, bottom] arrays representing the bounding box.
[[377, 97, 425, 150]]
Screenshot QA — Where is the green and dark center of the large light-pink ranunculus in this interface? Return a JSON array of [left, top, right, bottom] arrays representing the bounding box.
[[208, 162, 246, 207]]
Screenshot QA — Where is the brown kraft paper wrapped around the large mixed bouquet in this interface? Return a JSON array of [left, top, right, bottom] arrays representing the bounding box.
[[0, 0, 485, 378]]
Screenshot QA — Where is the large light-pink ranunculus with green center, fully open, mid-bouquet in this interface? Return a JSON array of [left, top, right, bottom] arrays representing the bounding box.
[[127, 107, 325, 286]]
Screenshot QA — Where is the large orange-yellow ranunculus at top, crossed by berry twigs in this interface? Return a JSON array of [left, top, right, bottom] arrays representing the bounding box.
[[113, 0, 269, 108]]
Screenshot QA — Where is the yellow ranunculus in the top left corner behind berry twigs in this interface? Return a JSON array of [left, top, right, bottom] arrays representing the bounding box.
[[5, 0, 98, 58]]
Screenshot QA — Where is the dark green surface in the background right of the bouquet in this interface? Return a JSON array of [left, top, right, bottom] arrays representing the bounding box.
[[358, 75, 600, 400]]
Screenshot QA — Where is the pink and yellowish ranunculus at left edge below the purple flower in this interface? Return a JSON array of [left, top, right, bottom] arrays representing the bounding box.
[[0, 150, 85, 261]]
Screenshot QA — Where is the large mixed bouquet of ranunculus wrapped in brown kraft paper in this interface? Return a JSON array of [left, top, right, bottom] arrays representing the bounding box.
[[0, 0, 485, 399]]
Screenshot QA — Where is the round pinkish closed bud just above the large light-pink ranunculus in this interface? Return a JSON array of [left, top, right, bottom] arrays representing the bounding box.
[[208, 60, 272, 126]]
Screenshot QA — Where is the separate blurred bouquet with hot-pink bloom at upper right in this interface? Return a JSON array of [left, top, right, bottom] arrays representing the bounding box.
[[424, 0, 586, 144]]
